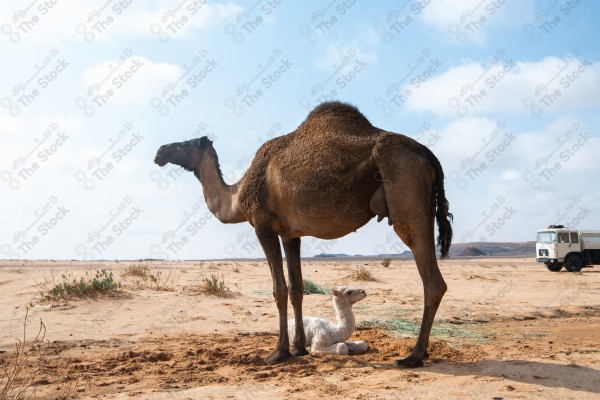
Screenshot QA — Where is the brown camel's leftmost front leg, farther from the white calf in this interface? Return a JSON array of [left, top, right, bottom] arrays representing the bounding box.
[[256, 228, 292, 364]]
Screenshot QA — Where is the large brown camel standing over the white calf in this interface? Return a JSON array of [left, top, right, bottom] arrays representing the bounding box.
[[154, 102, 452, 367]]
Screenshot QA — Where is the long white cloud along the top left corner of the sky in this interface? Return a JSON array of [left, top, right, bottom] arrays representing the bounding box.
[[0, 0, 241, 45]]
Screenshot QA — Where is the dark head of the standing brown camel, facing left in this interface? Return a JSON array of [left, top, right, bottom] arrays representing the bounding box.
[[154, 136, 212, 171]]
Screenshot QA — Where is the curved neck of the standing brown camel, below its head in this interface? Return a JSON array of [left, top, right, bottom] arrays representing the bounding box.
[[194, 147, 246, 224]]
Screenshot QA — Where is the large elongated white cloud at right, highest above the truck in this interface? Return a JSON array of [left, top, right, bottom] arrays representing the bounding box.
[[405, 55, 600, 116]]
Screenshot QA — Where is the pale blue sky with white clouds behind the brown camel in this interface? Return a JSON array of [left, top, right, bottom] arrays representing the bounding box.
[[0, 0, 600, 259]]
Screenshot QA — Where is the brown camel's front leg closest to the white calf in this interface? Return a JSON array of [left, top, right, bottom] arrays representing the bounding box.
[[281, 238, 308, 356]]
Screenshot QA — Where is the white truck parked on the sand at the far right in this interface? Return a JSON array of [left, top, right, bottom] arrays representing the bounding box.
[[535, 225, 600, 272]]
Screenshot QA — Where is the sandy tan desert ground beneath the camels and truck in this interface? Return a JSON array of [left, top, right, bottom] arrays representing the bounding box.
[[0, 259, 600, 400]]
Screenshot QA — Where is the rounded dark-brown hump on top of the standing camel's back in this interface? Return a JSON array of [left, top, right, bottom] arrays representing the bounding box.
[[298, 101, 373, 134]]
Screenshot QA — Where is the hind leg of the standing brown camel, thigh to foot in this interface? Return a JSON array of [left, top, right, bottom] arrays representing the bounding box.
[[376, 142, 447, 367]]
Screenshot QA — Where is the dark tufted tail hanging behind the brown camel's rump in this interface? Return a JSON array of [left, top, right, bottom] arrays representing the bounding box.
[[428, 151, 454, 258]]
